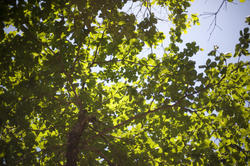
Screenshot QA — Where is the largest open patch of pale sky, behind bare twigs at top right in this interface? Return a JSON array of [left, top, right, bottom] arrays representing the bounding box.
[[183, 0, 250, 64]]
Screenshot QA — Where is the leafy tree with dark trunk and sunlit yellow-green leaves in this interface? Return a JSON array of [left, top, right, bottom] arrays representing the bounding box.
[[0, 0, 250, 166]]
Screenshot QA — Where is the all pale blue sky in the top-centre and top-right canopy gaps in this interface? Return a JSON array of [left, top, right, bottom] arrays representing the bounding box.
[[120, 0, 250, 71]]
